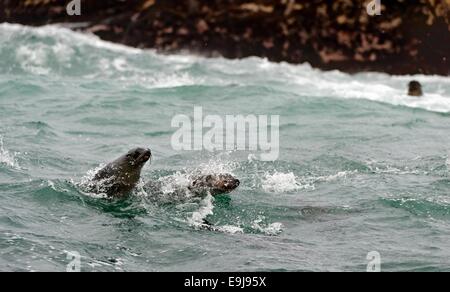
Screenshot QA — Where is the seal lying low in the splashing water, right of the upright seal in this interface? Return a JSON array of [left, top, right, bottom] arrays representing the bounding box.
[[144, 173, 241, 200]]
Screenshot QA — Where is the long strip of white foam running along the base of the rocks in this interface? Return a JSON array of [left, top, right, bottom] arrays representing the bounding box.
[[0, 23, 450, 113]]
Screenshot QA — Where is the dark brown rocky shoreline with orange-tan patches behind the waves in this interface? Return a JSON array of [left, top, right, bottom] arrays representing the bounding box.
[[0, 0, 450, 76]]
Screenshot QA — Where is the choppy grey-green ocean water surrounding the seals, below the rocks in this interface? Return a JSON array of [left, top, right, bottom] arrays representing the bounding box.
[[0, 24, 450, 271]]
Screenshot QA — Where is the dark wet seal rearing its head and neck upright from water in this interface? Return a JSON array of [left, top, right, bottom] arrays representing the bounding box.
[[88, 148, 152, 198]]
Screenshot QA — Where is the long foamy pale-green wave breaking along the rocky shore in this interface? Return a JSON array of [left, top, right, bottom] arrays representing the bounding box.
[[0, 23, 450, 113]]
